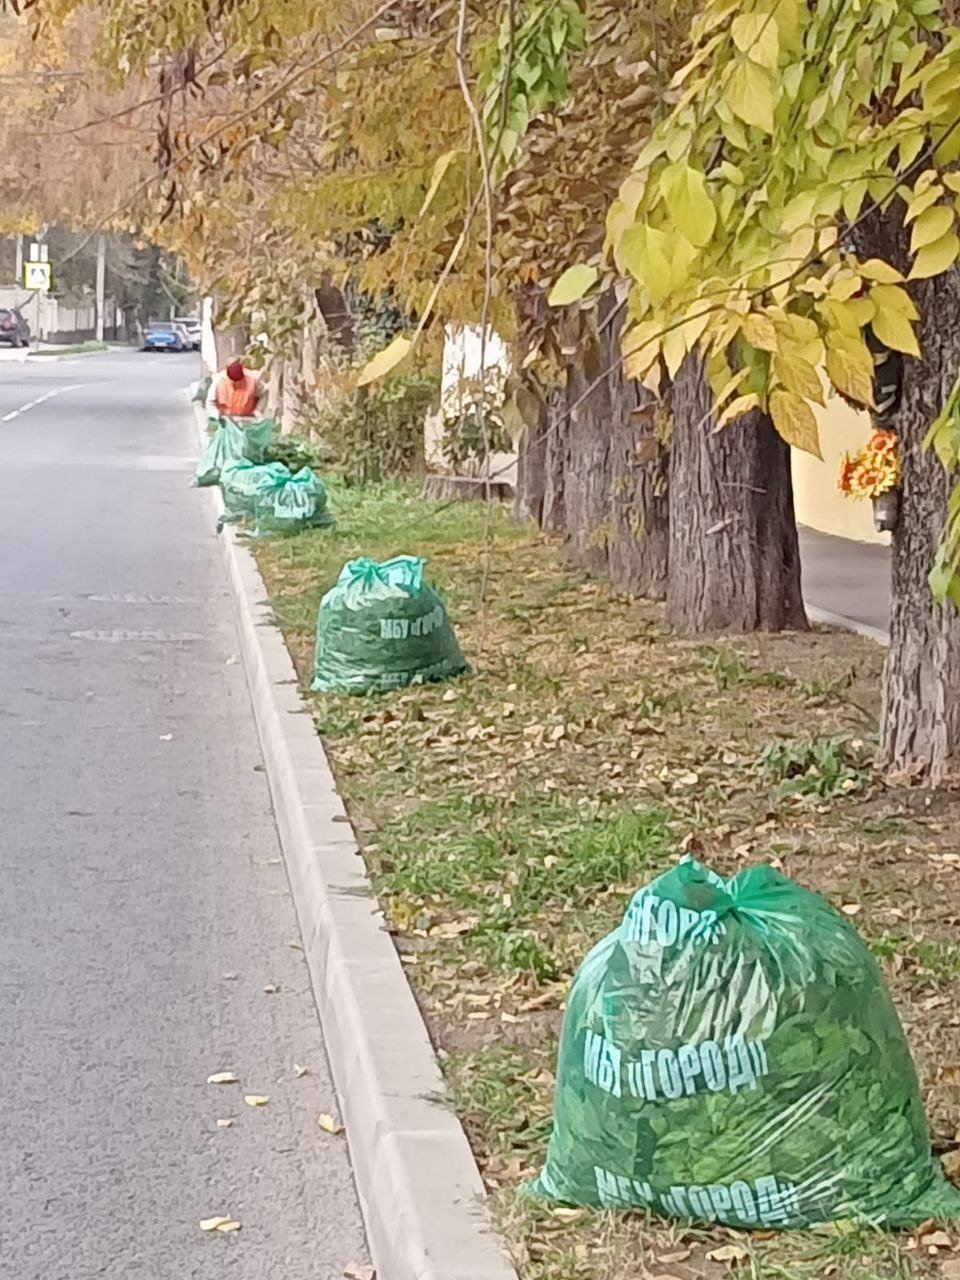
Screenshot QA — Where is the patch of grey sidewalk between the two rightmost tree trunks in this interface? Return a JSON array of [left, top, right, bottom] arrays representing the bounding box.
[[800, 527, 890, 644]]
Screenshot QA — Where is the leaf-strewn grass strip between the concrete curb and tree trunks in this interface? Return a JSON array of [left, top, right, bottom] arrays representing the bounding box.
[[256, 484, 960, 1280]]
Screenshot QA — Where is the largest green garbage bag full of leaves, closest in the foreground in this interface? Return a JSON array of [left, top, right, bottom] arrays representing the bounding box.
[[532, 860, 960, 1228]]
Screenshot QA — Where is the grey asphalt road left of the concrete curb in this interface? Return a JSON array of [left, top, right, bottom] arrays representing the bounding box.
[[0, 353, 366, 1280]]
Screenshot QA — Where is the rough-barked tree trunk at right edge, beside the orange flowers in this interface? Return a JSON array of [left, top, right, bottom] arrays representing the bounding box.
[[881, 270, 960, 783]]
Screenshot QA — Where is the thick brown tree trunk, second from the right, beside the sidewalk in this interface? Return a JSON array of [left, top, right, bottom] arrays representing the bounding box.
[[667, 358, 808, 632]]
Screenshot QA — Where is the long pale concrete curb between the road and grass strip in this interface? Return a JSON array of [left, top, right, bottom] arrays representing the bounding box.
[[195, 391, 516, 1280]]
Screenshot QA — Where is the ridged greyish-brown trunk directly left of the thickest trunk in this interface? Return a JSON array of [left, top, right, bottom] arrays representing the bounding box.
[[563, 294, 668, 599]]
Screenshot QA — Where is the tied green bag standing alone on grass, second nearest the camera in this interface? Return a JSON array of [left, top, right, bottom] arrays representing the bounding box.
[[314, 556, 470, 694]]
